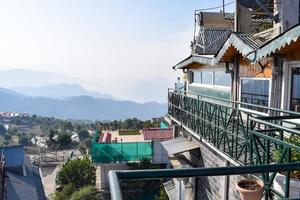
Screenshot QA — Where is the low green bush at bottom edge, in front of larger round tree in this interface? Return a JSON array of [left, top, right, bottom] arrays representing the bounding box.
[[70, 186, 103, 200]]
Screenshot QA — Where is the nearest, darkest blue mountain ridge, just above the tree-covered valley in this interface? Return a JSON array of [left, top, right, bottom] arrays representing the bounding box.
[[0, 89, 167, 120]]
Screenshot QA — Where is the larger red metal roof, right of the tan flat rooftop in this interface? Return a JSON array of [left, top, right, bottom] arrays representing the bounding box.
[[143, 128, 173, 140]]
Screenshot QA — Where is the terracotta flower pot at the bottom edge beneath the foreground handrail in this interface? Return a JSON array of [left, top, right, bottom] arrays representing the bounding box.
[[235, 179, 264, 200]]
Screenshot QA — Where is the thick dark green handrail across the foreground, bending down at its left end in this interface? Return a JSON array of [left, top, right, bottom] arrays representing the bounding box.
[[108, 162, 300, 200]]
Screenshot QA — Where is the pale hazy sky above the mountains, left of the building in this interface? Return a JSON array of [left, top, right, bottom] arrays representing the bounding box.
[[0, 0, 234, 102]]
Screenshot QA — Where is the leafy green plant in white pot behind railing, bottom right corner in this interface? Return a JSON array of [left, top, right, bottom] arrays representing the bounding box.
[[274, 135, 300, 198]]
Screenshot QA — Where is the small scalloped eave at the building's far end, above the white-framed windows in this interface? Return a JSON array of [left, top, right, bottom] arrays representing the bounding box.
[[173, 55, 214, 70]]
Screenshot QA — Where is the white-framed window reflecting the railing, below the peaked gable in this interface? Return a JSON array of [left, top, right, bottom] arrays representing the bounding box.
[[241, 79, 270, 112]]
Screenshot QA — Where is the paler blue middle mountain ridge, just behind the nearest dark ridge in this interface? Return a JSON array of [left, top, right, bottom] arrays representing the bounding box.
[[11, 83, 113, 99]]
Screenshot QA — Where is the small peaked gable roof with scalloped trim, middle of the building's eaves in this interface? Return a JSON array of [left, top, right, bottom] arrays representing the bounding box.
[[216, 33, 265, 62]]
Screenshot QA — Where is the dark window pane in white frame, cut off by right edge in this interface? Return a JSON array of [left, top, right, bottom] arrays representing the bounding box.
[[290, 68, 300, 112]]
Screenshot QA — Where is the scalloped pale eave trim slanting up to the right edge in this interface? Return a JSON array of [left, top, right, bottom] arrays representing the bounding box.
[[247, 24, 300, 62]]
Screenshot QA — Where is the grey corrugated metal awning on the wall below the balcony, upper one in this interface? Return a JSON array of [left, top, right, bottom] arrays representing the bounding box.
[[161, 136, 200, 156]]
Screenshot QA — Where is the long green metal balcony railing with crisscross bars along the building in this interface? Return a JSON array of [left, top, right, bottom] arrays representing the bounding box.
[[168, 89, 300, 199]]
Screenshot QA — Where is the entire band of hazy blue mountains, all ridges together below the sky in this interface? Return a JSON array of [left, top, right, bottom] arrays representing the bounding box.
[[0, 70, 166, 120]]
